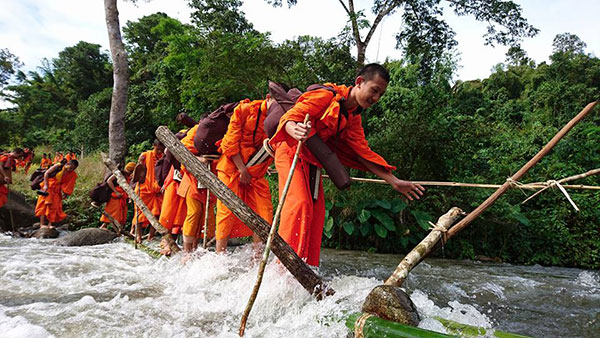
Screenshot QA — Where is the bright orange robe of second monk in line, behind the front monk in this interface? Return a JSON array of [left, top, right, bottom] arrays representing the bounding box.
[[216, 99, 273, 240]]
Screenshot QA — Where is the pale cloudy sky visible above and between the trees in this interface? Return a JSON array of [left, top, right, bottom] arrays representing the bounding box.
[[0, 0, 600, 80]]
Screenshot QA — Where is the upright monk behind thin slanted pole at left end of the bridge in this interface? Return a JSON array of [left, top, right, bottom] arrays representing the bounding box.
[[133, 139, 165, 243]]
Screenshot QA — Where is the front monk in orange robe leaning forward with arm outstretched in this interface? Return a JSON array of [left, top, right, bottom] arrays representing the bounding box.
[[270, 64, 425, 266]]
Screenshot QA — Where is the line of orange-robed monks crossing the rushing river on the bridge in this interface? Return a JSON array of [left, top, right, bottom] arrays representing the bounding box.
[[101, 64, 424, 266]]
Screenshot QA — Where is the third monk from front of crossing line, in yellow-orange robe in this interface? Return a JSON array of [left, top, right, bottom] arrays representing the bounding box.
[[177, 125, 216, 253]]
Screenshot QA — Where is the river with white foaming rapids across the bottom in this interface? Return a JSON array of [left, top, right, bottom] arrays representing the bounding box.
[[0, 235, 600, 338]]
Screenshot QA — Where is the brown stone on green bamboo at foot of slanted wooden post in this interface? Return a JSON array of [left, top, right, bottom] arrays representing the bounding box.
[[362, 285, 420, 326]]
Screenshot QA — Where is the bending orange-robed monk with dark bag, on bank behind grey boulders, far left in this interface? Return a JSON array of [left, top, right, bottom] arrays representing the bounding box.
[[35, 160, 79, 228]]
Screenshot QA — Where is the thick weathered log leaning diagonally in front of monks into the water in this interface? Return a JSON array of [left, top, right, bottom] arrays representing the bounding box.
[[156, 126, 334, 299]]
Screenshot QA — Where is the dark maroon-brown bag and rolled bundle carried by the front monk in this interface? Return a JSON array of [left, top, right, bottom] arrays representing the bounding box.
[[265, 81, 351, 190]]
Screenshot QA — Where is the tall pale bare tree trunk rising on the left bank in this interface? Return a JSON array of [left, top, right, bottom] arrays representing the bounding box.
[[104, 0, 129, 165]]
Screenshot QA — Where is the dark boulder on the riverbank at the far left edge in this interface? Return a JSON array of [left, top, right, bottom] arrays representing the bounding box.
[[0, 190, 37, 231]]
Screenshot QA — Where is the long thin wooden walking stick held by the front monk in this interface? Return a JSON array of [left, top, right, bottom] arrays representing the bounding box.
[[239, 114, 310, 337]]
